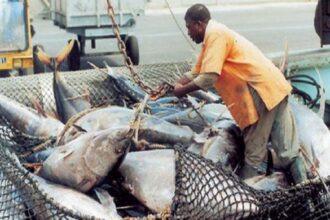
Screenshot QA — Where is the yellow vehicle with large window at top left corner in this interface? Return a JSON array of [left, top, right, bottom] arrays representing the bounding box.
[[0, 0, 33, 77]]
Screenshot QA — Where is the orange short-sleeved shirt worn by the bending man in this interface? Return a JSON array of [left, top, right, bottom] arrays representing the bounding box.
[[192, 20, 292, 129]]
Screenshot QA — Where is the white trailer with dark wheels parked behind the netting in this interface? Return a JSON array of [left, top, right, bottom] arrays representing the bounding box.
[[51, 0, 146, 70]]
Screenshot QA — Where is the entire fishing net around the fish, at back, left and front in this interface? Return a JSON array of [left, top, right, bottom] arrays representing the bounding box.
[[0, 63, 330, 219]]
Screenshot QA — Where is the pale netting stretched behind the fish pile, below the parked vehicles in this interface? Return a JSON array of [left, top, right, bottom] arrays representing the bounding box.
[[0, 62, 190, 111]]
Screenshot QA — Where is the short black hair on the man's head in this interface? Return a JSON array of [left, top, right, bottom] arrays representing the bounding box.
[[184, 4, 211, 22]]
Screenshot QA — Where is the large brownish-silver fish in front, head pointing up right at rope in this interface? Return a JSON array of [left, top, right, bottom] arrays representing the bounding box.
[[40, 127, 132, 192]]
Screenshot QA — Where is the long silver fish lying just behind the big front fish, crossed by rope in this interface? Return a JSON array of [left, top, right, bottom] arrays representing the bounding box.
[[59, 106, 194, 144]]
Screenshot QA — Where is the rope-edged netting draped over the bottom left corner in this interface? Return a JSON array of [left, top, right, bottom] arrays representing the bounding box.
[[0, 142, 100, 220]]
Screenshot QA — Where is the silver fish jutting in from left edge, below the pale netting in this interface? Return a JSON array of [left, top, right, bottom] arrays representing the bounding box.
[[0, 94, 64, 138]]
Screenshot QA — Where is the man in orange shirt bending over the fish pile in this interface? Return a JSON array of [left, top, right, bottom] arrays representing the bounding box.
[[173, 4, 307, 184]]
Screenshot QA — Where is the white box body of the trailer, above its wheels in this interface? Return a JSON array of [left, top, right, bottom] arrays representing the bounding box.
[[51, 0, 146, 29]]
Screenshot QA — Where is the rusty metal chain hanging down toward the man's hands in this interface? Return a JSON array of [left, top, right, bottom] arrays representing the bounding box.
[[107, 0, 173, 99]]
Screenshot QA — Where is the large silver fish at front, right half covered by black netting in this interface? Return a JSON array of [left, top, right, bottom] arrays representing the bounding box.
[[119, 150, 259, 219]]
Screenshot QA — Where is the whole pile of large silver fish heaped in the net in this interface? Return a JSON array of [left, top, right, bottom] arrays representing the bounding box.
[[0, 49, 330, 219]]
